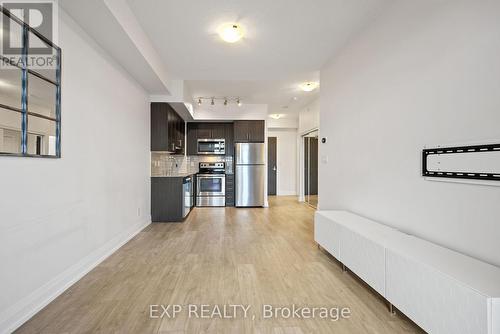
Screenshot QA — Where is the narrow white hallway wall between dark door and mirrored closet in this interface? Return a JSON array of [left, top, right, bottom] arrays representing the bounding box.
[[267, 128, 297, 196]]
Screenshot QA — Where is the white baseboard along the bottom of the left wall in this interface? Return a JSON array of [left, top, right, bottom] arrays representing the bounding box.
[[0, 220, 151, 334]]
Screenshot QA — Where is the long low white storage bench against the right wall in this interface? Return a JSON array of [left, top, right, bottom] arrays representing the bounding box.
[[314, 211, 500, 334]]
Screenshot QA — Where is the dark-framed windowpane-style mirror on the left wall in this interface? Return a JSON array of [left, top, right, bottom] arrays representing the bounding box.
[[0, 6, 61, 158]]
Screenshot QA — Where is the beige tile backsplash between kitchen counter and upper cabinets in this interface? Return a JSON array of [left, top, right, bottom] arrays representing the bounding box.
[[151, 152, 233, 176]]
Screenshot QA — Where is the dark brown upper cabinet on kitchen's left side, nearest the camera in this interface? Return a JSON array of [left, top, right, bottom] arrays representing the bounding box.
[[151, 102, 185, 154]]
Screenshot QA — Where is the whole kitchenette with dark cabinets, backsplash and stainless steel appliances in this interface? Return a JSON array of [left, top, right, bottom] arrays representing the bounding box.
[[151, 102, 267, 222]]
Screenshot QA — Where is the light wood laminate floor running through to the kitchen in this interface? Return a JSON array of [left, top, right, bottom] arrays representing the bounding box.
[[17, 197, 422, 334]]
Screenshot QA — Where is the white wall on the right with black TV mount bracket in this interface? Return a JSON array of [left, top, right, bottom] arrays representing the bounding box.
[[319, 1, 500, 265]]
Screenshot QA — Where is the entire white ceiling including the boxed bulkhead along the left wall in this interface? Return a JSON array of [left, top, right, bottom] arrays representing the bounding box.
[[61, 0, 393, 116]]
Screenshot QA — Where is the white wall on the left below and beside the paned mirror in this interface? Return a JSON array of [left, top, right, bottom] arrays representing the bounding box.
[[0, 10, 150, 333]]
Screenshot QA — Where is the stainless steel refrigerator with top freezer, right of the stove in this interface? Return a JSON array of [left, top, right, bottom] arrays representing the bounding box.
[[235, 143, 266, 206]]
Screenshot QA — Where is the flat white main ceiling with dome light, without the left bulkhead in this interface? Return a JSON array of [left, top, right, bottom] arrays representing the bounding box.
[[127, 0, 388, 116]]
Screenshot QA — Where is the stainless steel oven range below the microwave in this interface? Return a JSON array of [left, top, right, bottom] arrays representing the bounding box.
[[196, 162, 226, 206]]
